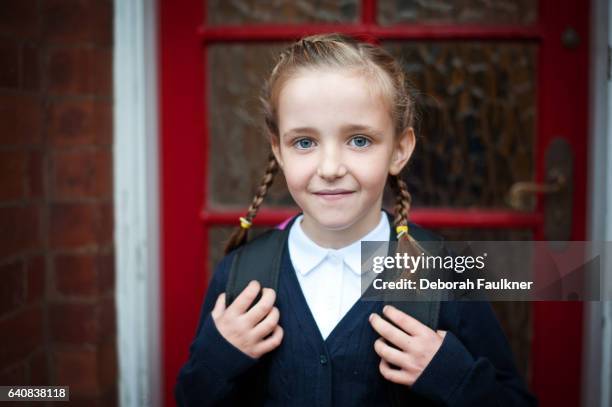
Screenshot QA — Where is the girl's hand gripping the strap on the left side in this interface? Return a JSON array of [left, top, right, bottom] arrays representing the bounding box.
[[211, 281, 283, 359]]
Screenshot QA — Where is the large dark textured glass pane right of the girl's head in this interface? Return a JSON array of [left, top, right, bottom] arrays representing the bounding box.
[[384, 42, 536, 208]]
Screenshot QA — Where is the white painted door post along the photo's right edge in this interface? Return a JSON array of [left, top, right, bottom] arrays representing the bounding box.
[[582, 0, 612, 407]]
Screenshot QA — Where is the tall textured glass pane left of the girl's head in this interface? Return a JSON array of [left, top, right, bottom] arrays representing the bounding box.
[[207, 43, 293, 209]]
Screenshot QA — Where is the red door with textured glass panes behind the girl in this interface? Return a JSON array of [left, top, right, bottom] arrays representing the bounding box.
[[159, 0, 589, 406]]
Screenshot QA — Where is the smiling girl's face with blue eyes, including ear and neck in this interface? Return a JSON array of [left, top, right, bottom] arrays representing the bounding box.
[[272, 70, 415, 247]]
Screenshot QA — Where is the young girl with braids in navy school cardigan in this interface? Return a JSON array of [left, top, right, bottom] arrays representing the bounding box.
[[175, 34, 536, 406]]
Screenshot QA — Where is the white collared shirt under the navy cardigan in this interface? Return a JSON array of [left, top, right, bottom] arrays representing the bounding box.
[[288, 211, 390, 339]]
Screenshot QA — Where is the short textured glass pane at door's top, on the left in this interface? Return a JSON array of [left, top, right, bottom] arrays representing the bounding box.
[[207, 0, 360, 25]]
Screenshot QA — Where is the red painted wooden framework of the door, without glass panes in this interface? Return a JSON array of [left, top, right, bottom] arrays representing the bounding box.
[[158, 0, 589, 406]]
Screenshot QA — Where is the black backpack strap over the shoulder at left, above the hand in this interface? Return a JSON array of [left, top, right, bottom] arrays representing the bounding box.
[[225, 217, 295, 306]]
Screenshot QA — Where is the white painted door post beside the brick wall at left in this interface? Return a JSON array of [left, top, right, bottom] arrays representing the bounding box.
[[113, 0, 163, 407]]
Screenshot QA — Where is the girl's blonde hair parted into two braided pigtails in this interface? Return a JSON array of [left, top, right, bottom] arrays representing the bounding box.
[[225, 33, 415, 253]]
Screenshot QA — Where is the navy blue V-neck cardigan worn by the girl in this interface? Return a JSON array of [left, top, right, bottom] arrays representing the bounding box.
[[175, 231, 537, 407]]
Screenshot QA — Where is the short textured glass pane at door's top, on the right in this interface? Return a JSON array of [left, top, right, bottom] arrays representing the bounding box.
[[378, 0, 538, 25]]
